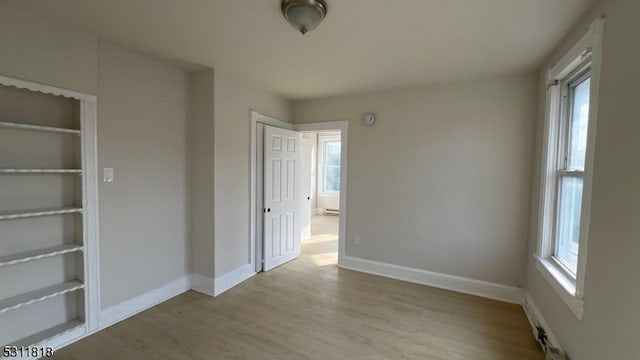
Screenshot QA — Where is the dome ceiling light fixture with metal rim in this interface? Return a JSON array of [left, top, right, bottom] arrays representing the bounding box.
[[281, 0, 327, 35]]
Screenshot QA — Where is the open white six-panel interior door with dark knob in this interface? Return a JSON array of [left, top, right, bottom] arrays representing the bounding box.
[[263, 126, 301, 271]]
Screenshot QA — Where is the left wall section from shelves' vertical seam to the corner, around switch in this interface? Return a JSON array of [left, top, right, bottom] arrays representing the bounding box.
[[98, 43, 190, 308]]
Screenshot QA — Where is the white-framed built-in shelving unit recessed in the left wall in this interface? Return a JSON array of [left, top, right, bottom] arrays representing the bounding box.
[[0, 75, 99, 352]]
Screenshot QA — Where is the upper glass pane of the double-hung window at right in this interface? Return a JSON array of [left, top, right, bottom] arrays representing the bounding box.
[[567, 77, 591, 170]]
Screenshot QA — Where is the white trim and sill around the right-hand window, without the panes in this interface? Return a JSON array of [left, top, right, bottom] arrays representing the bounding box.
[[535, 18, 605, 319]]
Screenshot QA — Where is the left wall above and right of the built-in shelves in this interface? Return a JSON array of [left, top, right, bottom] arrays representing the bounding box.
[[0, 3, 190, 307]]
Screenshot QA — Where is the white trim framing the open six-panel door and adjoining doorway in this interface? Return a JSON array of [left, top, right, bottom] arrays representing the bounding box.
[[249, 110, 349, 272]]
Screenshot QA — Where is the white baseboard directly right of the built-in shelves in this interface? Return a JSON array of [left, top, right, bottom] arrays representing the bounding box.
[[99, 274, 191, 329]]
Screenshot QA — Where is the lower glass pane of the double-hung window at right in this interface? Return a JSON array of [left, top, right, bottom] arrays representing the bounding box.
[[555, 177, 582, 273]]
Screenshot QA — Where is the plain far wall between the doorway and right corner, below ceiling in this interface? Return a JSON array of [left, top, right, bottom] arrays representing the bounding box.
[[293, 74, 537, 285]]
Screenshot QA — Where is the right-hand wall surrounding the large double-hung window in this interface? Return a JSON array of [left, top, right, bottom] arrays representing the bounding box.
[[527, 0, 640, 360]]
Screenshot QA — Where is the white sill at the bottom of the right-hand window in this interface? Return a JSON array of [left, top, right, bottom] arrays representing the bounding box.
[[535, 256, 584, 320]]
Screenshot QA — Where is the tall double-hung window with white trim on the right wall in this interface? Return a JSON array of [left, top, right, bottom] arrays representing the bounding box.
[[536, 19, 604, 318]]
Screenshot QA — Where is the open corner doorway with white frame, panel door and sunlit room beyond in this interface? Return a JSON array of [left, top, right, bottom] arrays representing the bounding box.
[[249, 111, 348, 272]]
